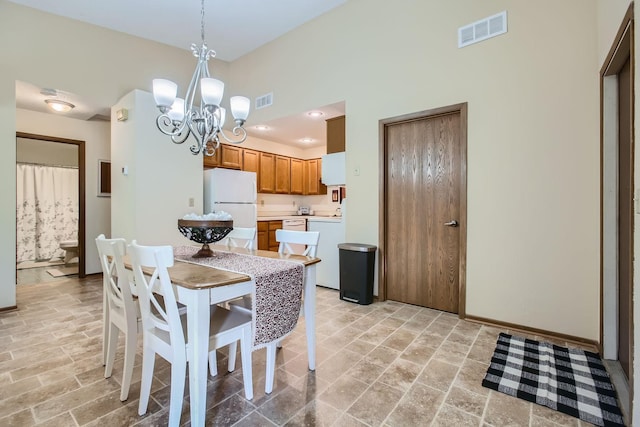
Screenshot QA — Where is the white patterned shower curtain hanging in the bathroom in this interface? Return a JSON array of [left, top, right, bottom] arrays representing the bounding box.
[[16, 164, 79, 262]]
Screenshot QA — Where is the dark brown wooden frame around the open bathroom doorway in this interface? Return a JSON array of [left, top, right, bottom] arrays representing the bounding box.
[[16, 132, 86, 278]]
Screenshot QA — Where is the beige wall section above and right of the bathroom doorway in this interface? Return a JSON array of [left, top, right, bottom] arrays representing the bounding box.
[[13, 110, 111, 274]]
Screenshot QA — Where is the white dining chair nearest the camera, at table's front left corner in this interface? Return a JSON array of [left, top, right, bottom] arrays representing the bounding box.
[[129, 241, 253, 426]]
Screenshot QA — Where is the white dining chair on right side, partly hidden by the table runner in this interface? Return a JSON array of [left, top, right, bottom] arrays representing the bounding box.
[[229, 230, 320, 393]]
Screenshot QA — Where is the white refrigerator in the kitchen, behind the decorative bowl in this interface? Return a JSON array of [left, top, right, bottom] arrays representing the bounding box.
[[203, 168, 258, 234]]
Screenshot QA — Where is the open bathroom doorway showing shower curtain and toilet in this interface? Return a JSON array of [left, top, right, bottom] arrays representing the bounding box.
[[16, 132, 86, 284]]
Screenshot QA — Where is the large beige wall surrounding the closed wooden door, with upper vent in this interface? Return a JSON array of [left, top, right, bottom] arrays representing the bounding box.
[[230, 0, 599, 340]]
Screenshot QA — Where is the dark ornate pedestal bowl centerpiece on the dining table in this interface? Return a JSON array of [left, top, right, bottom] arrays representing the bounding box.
[[178, 211, 233, 258]]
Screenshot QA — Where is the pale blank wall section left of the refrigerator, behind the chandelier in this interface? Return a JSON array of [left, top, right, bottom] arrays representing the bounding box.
[[111, 90, 203, 245]]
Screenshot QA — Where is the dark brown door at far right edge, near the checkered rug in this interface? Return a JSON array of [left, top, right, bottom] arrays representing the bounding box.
[[618, 58, 633, 378]]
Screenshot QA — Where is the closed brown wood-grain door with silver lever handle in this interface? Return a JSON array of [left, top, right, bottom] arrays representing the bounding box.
[[384, 104, 466, 313]]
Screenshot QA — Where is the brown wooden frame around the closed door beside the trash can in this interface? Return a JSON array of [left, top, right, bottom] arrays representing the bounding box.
[[378, 102, 467, 319]]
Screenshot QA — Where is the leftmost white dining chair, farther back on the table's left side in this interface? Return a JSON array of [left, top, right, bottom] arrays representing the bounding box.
[[96, 234, 142, 401]]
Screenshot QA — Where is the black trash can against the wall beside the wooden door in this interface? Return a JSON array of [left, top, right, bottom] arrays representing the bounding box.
[[338, 243, 377, 305]]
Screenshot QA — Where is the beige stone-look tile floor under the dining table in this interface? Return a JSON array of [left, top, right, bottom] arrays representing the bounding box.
[[0, 275, 624, 427]]
